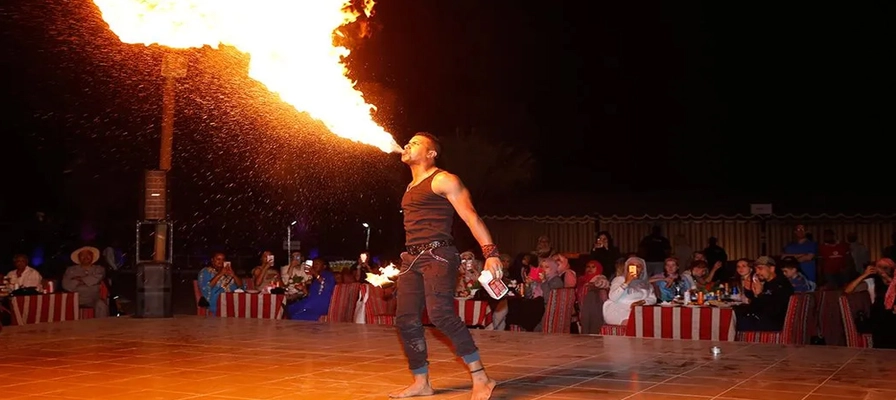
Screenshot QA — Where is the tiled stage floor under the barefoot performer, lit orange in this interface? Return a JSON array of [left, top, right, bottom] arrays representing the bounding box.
[[0, 317, 896, 400]]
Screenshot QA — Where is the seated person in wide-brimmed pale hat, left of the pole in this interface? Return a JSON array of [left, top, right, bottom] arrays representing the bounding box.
[[62, 246, 109, 318]]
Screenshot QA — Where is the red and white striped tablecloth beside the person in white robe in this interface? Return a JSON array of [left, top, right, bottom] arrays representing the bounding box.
[[627, 306, 735, 341]]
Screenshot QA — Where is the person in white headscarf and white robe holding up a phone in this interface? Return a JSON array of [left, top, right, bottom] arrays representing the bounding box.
[[604, 257, 656, 325]]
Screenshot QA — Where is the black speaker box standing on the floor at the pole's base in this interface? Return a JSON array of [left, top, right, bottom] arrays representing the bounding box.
[[134, 262, 174, 318]]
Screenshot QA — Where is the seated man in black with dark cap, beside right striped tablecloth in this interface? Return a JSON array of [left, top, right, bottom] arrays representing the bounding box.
[[734, 256, 793, 331]]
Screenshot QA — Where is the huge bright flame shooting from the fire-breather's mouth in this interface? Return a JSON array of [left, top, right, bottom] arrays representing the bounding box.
[[93, 0, 401, 152]]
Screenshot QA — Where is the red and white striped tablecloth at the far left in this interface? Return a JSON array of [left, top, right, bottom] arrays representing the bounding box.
[[10, 292, 80, 325]]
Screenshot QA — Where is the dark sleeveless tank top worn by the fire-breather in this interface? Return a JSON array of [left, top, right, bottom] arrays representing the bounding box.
[[401, 169, 454, 246]]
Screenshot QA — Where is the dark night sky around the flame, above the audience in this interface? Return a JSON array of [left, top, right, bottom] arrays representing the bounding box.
[[0, 0, 896, 253]]
